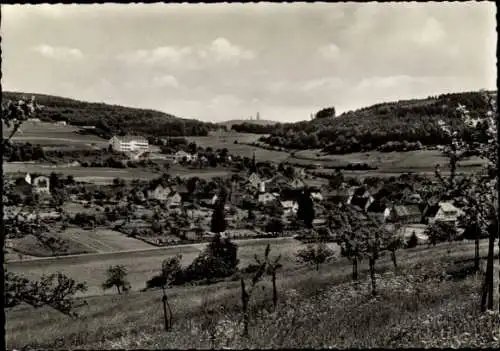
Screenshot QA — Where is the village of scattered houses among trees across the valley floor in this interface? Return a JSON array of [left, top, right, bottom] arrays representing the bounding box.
[[2, 132, 468, 255]]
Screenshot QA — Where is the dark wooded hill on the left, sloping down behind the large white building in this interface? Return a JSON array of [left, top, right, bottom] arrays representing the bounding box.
[[2, 92, 216, 138]]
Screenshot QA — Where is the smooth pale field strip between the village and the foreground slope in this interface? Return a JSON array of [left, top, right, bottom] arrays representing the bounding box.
[[7, 236, 314, 295]]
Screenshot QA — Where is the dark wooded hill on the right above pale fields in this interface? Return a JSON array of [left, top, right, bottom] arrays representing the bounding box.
[[258, 92, 496, 154]]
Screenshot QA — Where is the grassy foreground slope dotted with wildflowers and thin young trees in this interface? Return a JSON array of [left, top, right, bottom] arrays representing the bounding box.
[[6, 242, 498, 349]]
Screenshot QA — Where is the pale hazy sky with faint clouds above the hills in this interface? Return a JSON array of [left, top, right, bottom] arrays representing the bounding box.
[[1, 2, 496, 121]]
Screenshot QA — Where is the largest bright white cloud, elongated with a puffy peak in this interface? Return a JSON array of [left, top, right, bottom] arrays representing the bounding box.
[[117, 37, 255, 68]]
